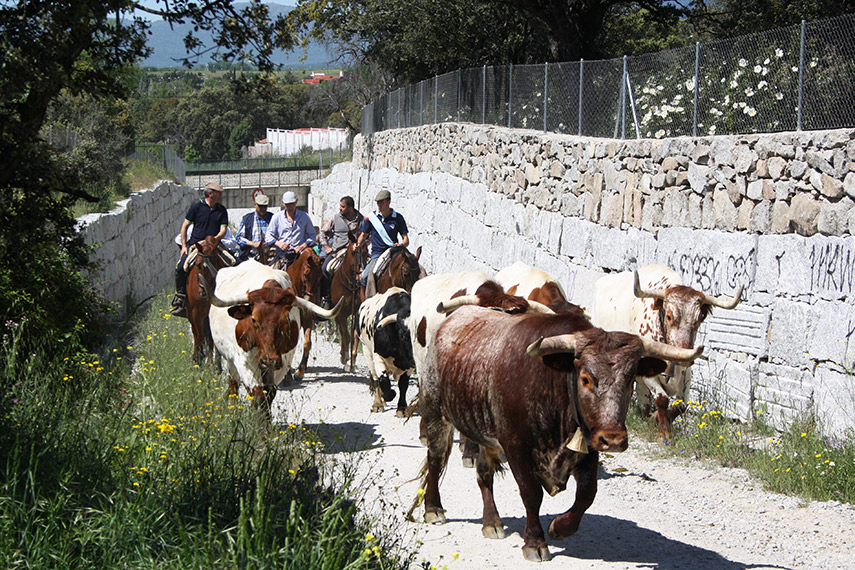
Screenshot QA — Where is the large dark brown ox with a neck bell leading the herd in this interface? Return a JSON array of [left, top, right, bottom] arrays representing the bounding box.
[[420, 307, 702, 561]]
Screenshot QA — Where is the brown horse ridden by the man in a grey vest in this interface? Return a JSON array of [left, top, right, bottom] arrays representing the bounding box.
[[330, 233, 368, 372]]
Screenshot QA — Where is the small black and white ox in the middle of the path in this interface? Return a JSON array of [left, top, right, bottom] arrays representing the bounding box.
[[357, 287, 415, 417]]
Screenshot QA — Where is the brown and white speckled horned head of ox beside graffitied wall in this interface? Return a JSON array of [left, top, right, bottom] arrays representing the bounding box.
[[633, 271, 743, 348]]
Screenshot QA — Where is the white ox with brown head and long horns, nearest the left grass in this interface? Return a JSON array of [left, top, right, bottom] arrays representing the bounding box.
[[206, 260, 339, 410]]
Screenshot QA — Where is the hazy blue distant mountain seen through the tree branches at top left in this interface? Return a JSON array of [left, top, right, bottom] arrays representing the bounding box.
[[141, 3, 333, 69]]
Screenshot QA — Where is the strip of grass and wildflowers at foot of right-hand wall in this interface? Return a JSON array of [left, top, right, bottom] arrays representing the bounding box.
[[627, 394, 855, 503]]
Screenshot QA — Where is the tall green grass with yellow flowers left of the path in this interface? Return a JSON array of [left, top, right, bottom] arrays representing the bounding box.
[[0, 296, 411, 570]]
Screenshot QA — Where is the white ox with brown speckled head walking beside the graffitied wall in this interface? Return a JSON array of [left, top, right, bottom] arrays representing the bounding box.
[[592, 265, 742, 440]]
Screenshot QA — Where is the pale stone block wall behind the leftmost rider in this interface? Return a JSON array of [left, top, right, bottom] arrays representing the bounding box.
[[78, 181, 199, 312]]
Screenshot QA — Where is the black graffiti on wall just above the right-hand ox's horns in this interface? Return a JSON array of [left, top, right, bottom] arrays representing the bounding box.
[[668, 248, 756, 299]]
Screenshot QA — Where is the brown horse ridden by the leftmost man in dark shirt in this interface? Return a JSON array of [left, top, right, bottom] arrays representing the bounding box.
[[187, 236, 226, 364]]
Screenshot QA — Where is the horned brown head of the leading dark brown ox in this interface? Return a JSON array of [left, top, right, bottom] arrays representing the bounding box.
[[526, 328, 703, 451]]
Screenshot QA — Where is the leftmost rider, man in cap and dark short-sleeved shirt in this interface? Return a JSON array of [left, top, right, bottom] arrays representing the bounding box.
[[171, 182, 229, 317]]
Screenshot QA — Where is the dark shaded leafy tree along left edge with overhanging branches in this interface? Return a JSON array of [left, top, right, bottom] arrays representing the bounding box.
[[0, 0, 292, 342]]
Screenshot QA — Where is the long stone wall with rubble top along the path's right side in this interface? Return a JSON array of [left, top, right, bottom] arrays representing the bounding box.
[[309, 124, 855, 433]]
